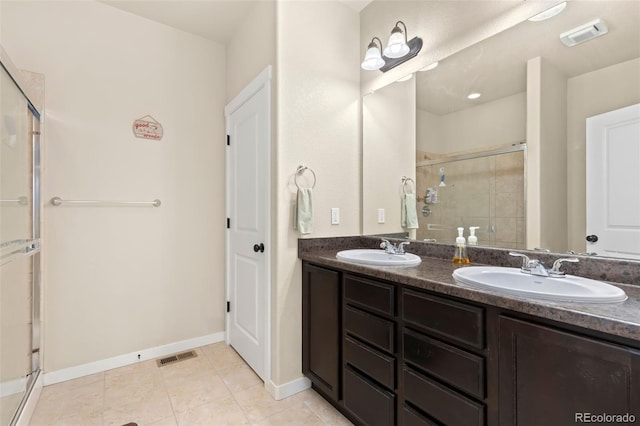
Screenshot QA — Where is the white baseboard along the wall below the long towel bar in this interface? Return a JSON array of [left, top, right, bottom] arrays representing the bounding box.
[[44, 331, 225, 386]]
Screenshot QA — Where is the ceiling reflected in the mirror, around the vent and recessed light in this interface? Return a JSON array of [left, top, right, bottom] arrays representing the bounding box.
[[416, 0, 640, 115]]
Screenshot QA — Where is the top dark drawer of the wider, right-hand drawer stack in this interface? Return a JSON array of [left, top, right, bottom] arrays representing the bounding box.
[[402, 290, 484, 349]]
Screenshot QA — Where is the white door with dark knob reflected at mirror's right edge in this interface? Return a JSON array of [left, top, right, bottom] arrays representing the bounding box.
[[586, 104, 640, 259]]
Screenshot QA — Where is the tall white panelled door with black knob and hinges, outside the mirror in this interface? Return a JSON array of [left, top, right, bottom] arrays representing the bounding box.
[[225, 68, 270, 380]]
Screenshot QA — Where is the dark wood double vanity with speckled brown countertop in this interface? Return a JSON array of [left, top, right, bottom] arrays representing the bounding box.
[[300, 237, 640, 426]]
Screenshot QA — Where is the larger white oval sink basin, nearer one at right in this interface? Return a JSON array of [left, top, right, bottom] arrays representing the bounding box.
[[453, 266, 627, 303]]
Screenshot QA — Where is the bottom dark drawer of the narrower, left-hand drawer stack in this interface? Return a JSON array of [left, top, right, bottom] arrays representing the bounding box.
[[343, 366, 396, 426]]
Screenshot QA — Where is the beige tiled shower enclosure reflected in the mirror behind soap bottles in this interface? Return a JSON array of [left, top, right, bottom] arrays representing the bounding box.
[[416, 143, 526, 249]]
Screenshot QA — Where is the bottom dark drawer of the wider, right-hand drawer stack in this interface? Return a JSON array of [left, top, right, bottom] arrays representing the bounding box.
[[402, 367, 485, 426]]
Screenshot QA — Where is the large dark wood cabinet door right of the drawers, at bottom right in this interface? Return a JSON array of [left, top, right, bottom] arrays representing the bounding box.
[[499, 317, 640, 426]]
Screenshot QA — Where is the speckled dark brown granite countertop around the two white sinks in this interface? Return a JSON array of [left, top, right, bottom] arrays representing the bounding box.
[[299, 244, 640, 342]]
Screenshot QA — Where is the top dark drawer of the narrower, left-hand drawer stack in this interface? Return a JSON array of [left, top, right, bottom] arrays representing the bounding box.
[[344, 275, 396, 316]]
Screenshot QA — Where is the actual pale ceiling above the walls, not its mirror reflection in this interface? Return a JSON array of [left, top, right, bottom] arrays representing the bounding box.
[[97, 0, 372, 44]]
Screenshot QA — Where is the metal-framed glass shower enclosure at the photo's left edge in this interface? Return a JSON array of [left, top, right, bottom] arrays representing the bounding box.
[[0, 57, 40, 426]]
